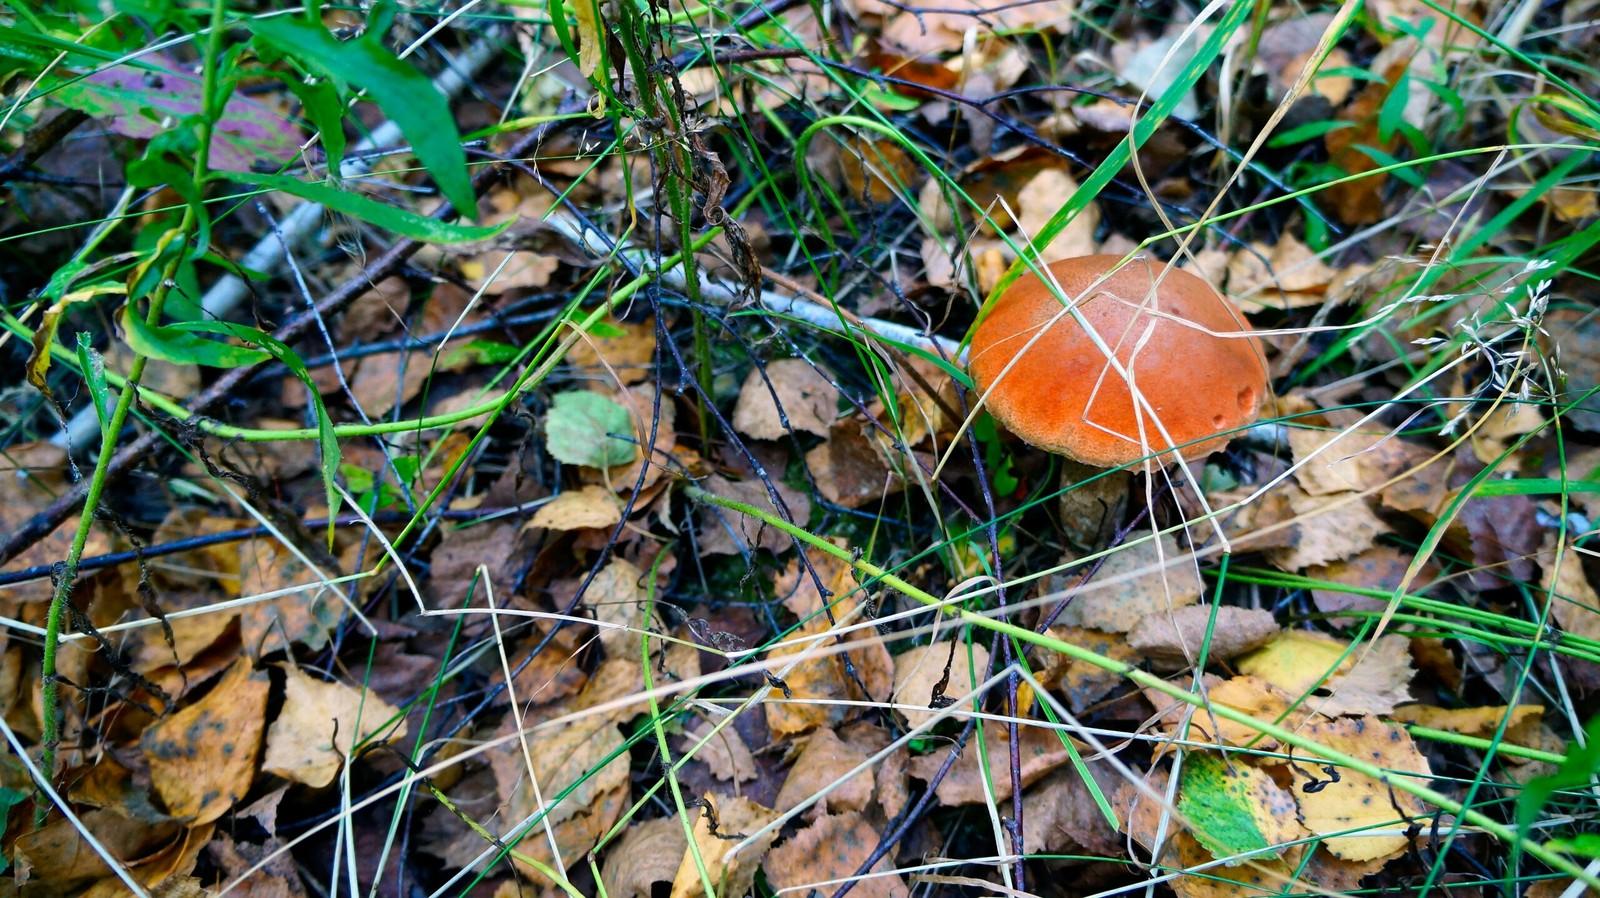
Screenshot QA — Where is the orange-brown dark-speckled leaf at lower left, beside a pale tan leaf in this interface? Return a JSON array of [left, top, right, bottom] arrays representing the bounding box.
[[139, 658, 272, 826]]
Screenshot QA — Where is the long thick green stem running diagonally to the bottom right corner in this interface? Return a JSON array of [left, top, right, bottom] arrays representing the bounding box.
[[685, 487, 1600, 888]]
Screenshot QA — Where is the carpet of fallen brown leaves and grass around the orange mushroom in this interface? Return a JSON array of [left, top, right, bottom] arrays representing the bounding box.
[[0, 0, 1600, 898]]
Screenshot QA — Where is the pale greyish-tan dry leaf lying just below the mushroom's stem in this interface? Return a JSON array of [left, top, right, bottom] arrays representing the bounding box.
[[1058, 533, 1203, 632]]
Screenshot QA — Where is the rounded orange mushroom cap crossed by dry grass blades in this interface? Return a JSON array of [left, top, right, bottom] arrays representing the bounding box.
[[968, 249, 1267, 467]]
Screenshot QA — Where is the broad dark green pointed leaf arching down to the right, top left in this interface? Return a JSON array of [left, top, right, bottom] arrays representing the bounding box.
[[250, 16, 478, 218]]
